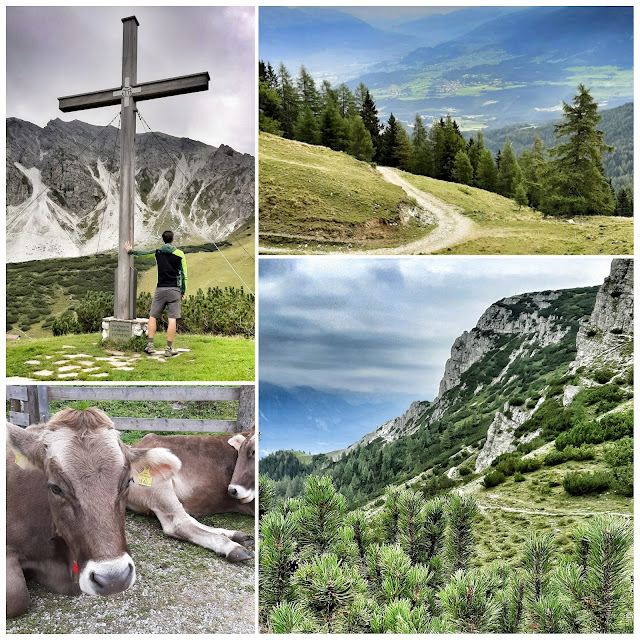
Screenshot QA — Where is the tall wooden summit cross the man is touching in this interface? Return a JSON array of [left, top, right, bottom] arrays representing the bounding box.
[[58, 16, 209, 324]]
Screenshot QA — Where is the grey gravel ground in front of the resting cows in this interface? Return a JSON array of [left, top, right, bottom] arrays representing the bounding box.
[[7, 513, 255, 634]]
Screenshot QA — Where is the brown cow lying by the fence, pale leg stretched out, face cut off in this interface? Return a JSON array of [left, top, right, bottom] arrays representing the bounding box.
[[127, 427, 255, 562]]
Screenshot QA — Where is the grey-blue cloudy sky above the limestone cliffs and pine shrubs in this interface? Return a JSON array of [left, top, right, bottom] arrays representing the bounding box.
[[260, 256, 611, 399]]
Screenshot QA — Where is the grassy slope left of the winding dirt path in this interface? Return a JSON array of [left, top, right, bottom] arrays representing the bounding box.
[[260, 133, 426, 249]]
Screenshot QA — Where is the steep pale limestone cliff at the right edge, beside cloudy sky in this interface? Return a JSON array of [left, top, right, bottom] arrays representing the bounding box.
[[573, 259, 633, 370]]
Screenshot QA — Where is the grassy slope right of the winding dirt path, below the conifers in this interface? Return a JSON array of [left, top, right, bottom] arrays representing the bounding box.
[[402, 173, 633, 255]]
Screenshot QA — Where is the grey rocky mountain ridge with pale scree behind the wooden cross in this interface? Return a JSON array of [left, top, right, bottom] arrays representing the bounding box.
[[6, 118, 255, 262]]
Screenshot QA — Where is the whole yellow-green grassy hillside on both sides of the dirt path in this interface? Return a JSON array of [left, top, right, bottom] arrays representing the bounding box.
[[260, 133, 633, 255]]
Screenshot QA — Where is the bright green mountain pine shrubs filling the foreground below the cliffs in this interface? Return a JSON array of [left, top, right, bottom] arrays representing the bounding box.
[[259, 472, 633, 634]]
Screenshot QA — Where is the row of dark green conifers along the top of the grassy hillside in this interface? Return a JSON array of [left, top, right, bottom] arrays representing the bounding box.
[[259, 61, 633, 218]]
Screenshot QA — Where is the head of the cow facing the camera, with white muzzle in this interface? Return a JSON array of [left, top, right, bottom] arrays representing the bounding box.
[[7, 409, 181, 596]]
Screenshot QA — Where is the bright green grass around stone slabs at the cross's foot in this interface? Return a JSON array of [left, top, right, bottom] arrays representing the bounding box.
[[6, 333, 255, 382]]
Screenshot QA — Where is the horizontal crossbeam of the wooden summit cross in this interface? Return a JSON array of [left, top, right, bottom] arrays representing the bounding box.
[[58, 71, 210, 113]]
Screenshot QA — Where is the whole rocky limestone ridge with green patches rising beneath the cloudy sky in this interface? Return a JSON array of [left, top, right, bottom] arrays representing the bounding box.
[[347, 259, 633, 473]]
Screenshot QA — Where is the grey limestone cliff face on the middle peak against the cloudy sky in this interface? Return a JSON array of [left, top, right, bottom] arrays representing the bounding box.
[[438, 291, 569, 397]]
